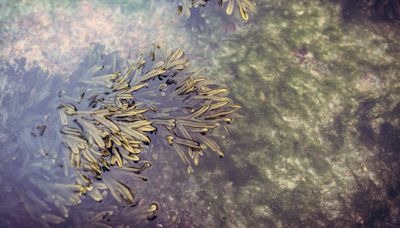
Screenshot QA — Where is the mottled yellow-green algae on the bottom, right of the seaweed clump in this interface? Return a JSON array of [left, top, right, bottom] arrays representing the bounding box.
[[184, 1, 400, 227]]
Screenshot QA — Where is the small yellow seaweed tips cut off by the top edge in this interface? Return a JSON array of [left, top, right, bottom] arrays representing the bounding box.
[[178, 0, 256, 21]]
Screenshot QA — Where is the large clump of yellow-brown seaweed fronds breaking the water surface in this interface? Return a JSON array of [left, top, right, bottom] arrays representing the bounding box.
[[59, 43, 239, 176]]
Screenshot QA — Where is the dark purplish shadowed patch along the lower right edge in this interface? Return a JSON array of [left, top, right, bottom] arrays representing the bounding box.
[[345, 96, 400, 227]]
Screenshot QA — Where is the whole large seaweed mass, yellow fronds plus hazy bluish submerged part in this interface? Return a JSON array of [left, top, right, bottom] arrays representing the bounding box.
[[0, 42, 239, 226]]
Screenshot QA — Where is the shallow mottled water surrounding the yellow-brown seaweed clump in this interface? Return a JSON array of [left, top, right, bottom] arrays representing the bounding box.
[[0, 0, 400, 227]]
